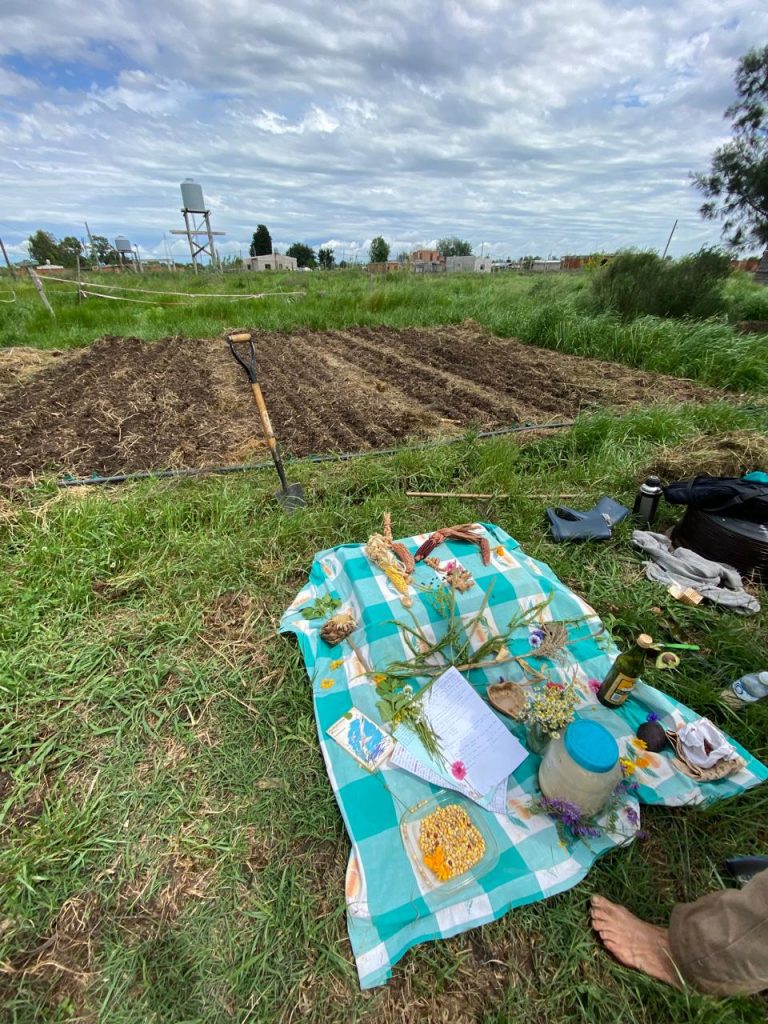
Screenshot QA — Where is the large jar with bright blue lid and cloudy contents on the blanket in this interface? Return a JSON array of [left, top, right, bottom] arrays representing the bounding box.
[[539, 719, 622, 817]]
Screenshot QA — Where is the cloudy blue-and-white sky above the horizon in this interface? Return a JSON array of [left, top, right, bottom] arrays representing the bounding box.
[[0, 0, 768, 259]]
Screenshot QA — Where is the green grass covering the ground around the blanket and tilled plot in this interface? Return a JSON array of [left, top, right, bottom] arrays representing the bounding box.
[[0, 272, 768, 1024]]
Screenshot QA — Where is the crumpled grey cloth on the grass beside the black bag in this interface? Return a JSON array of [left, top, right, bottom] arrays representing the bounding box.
[[632, 529, 760, 615]]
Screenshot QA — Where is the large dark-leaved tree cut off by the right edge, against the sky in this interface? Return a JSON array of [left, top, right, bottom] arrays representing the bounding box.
[[693, 46, 768, 249]]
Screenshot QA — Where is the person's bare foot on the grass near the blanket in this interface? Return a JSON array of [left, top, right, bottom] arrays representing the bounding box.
[[592, 896, 683, 988]]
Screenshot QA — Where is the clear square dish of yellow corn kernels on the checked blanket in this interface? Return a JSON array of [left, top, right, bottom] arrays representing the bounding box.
[[400, 790, 499, 895]]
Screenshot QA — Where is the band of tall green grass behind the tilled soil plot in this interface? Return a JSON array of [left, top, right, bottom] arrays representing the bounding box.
[[0, 270, 768, 393]]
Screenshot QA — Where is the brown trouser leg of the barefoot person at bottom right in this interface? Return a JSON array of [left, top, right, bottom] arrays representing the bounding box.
[[670, 869, 768, 995]]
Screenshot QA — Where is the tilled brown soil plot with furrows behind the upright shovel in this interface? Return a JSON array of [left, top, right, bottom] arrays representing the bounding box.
[[0, 323, 715, 479]]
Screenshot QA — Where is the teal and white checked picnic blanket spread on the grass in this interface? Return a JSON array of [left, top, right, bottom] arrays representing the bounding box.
[[281, 524, 768, 988]]
